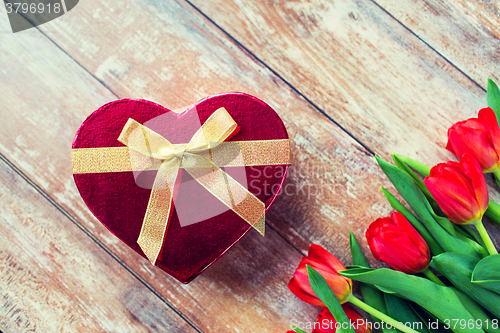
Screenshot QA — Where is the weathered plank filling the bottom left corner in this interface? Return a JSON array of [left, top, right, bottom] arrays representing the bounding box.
[[0, 153, 195, 333]]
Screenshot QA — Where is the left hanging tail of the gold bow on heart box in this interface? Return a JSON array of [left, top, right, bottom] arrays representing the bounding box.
[[137, 159, 180, 265]]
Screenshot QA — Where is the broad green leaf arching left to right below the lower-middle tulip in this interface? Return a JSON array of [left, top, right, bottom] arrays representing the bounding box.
[[339, 266, 484, 333]]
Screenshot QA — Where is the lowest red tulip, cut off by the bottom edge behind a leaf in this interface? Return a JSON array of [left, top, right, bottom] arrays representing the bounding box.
[[312, 304, 372, 333]]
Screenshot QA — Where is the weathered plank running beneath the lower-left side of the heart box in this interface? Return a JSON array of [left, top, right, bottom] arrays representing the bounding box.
[[0, 7, 330, 332]]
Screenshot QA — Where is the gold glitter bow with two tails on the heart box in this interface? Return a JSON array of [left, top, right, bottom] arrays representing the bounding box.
[[118, 108, 265, 265]]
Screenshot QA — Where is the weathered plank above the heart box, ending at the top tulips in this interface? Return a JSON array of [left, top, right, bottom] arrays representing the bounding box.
[[187, 0, 488, 158]]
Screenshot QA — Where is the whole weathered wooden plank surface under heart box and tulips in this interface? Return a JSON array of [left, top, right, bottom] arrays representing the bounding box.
[[0, 0, 500, 333]]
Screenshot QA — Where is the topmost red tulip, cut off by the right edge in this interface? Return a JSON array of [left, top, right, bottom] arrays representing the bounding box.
[[446, 108, 500, 172]]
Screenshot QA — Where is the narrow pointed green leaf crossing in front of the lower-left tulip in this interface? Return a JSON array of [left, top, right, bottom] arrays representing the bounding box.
[[306, 265, 356, 333]]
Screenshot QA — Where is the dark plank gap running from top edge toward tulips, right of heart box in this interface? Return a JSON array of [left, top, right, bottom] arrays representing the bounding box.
[[184, 0, 375, 156]]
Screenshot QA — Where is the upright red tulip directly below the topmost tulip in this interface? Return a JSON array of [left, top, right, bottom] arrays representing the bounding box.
[[424, 153, 489, 224]]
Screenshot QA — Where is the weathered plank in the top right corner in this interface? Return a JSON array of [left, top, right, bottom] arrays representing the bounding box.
[[375, 0, 500, 89]]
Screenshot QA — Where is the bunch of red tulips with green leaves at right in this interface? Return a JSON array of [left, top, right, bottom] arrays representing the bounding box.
[[288, 80, 500, 333]]
